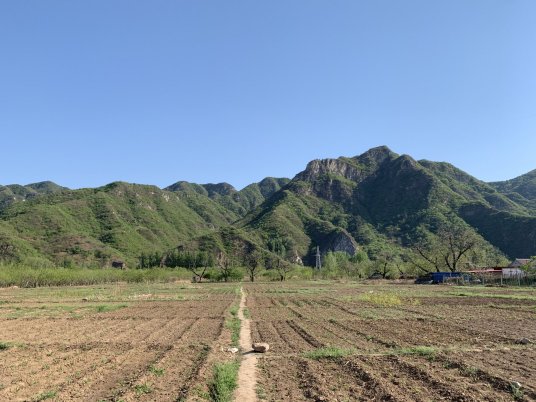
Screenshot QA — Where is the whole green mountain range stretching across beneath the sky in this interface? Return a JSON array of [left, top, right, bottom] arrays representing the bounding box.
[[0, 146, 536, 266]]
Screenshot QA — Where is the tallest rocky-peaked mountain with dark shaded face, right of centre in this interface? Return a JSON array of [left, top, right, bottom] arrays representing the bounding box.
[[240, 147, 536, 262]]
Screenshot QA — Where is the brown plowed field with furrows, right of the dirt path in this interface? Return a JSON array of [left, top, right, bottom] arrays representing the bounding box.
[[245, 283, 536, 401]]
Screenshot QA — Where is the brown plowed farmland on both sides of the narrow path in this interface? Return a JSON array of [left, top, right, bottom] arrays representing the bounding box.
[[0, 281, 536, 401]]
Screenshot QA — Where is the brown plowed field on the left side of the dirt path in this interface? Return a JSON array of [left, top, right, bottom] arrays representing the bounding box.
[[0, 284, 239, 401]]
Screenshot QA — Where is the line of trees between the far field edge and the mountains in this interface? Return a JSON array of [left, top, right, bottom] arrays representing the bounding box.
[[132, 223, 507, 281]]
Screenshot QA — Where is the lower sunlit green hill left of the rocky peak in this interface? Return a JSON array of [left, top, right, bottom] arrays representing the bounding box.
[[0, 183, 236, 265]]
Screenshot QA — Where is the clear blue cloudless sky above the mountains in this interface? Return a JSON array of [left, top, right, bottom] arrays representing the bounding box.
[[0, 0, 536, 188]]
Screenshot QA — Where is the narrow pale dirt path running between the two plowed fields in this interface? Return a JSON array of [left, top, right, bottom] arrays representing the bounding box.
[[235, 289, 257, 402]]
